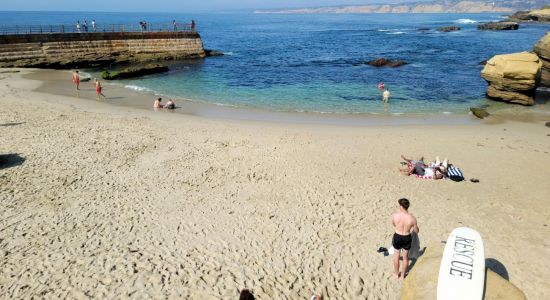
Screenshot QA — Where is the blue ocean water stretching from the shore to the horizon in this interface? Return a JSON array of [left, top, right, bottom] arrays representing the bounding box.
[[0, 12, 550, 114]]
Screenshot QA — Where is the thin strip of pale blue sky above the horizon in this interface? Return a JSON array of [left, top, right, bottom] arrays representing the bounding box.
[[0, 0, 432, 13]]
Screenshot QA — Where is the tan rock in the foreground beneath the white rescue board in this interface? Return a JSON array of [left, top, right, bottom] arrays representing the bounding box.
[[401, 245, 527, 300]]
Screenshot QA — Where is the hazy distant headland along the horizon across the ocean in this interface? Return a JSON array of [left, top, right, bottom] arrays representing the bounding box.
[[255, 0, 548, 14]]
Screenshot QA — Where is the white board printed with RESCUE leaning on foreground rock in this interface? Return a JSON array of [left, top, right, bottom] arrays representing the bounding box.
[[437, 227, 485, 300]]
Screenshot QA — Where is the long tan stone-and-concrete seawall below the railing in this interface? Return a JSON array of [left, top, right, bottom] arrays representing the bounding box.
[[0, 31, 205, 68]]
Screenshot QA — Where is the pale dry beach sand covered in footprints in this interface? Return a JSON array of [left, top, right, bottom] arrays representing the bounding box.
[[0, 71, 550, 299]]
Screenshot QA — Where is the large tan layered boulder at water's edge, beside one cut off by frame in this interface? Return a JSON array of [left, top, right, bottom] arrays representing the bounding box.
[[481, 52, 542, 105]]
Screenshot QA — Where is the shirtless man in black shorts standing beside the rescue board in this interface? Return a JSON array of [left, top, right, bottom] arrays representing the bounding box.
[[392, 198, 419, 279]]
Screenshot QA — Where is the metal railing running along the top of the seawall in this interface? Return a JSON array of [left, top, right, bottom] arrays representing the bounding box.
[[0, 23, 196, 35]]
